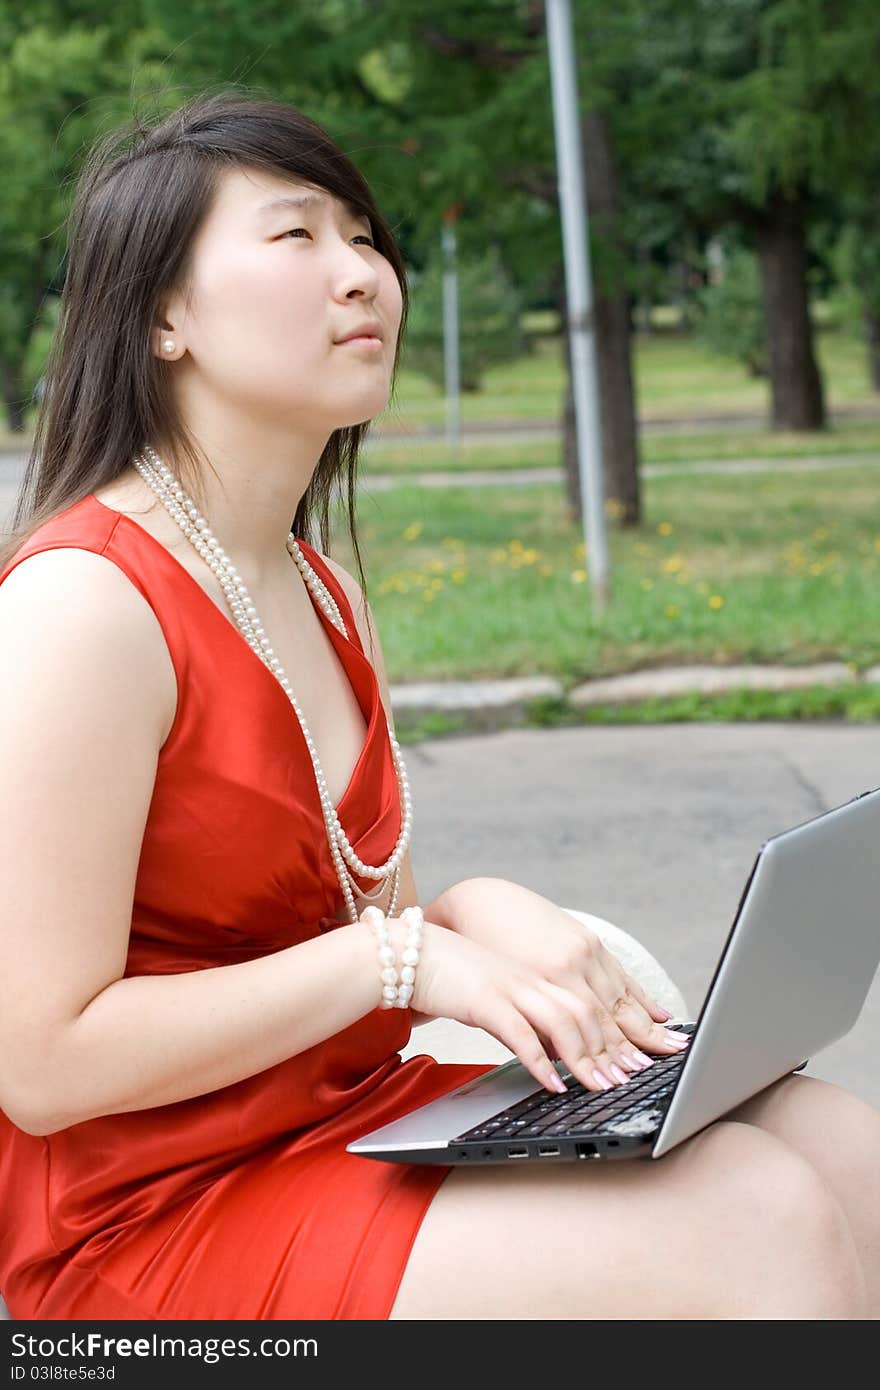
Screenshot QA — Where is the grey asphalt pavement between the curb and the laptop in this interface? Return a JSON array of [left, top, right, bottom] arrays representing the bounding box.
[[403, 723, 880, 1108]]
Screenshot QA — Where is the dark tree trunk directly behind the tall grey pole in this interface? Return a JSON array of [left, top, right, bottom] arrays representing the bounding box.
[[560, 111, 641, 527]]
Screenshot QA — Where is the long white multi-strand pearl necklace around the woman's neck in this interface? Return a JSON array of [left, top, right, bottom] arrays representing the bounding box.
[[132, 445, 413, 922]]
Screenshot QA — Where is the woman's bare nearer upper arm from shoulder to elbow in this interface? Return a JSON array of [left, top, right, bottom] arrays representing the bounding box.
[[0, 548, 177, 1134]]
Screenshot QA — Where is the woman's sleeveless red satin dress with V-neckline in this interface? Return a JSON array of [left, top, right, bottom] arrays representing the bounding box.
[[0, 493, 488, 1319]]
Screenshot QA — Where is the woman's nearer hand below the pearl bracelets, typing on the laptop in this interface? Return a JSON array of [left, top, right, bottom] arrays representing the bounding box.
[[389, 919, 689, 1091]]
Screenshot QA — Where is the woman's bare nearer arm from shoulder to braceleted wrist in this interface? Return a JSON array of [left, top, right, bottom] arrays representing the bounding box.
[[0, 536, 458, 1134]]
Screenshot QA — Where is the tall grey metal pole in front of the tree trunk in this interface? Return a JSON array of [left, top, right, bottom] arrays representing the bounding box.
[[545, 0, 610, 610]]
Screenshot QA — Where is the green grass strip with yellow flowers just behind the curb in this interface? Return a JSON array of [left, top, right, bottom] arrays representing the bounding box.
[[326, 466, 880, 684]]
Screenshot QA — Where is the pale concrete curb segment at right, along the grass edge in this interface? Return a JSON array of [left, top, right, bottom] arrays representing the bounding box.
[[569, 662, 856, 706]]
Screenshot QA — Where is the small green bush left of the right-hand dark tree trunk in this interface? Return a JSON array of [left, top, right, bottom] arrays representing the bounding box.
[[694, 247, 767, 377]]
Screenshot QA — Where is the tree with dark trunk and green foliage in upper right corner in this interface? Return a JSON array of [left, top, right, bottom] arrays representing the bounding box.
[[625, 0, 880, 430]]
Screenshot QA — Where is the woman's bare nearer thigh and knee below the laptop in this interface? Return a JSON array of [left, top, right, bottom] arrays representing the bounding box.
[[389, 1120, 851, 1319]]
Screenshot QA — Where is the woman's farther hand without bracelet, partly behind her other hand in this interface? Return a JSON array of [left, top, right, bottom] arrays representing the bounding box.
[[428, 878, 687, 1080]]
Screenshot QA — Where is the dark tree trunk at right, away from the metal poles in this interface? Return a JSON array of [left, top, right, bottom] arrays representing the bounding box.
[[756, 193, 826, 430]]
